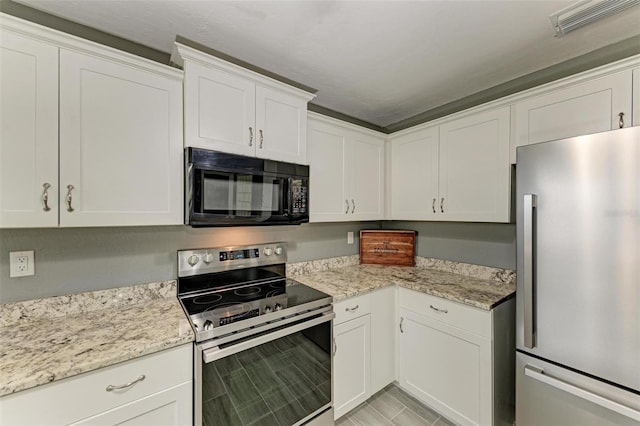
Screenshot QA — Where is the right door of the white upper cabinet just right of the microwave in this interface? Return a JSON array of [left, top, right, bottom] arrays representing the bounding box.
[[346, 132, 384, 220]]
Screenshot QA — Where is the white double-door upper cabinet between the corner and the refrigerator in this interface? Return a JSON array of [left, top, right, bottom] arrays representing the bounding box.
[[391, 107, 510, 222]]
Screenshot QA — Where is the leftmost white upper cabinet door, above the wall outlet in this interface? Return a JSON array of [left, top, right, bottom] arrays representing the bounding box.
[[0, 30, 59, 228]]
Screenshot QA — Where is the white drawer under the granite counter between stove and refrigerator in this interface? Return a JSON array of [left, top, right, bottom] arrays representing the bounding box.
[[400, 288, 491, 339]]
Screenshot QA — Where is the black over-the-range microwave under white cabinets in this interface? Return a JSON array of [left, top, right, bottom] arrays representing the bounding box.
[[184, 147, 309, 227]]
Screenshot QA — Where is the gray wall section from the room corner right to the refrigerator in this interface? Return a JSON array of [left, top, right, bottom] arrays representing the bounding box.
[[382, 221, 516, 269]]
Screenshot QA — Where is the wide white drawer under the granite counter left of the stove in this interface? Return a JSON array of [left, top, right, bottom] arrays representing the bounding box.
[[0, 344, 193, 425]]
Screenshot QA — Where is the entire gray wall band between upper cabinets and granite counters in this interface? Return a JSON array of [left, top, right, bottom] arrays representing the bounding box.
[[0, 222, 515, 303]]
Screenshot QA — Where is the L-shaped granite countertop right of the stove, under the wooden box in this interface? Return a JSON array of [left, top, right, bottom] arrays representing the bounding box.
[[292, 259, 516, 310]]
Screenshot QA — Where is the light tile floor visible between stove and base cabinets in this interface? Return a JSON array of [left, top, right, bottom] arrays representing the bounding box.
[[336, 384, 453, 426]]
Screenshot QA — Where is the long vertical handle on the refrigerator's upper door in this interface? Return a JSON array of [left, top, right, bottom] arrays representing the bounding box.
[[522, 194, 537, 349]]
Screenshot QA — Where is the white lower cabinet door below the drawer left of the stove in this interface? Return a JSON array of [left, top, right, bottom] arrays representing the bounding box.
[[73, 382, 193, 426]]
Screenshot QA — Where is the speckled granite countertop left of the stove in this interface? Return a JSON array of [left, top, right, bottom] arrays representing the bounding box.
[[0, 281, 194, 396]]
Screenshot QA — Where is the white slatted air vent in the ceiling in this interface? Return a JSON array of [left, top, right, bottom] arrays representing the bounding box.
[[549, 0, 640, 37]]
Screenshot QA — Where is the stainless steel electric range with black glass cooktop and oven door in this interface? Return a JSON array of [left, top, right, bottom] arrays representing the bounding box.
[[178, 243, 335, 426]]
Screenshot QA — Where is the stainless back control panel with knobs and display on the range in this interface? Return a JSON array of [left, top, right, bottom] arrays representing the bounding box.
[[178, 242, 287, 277]]
